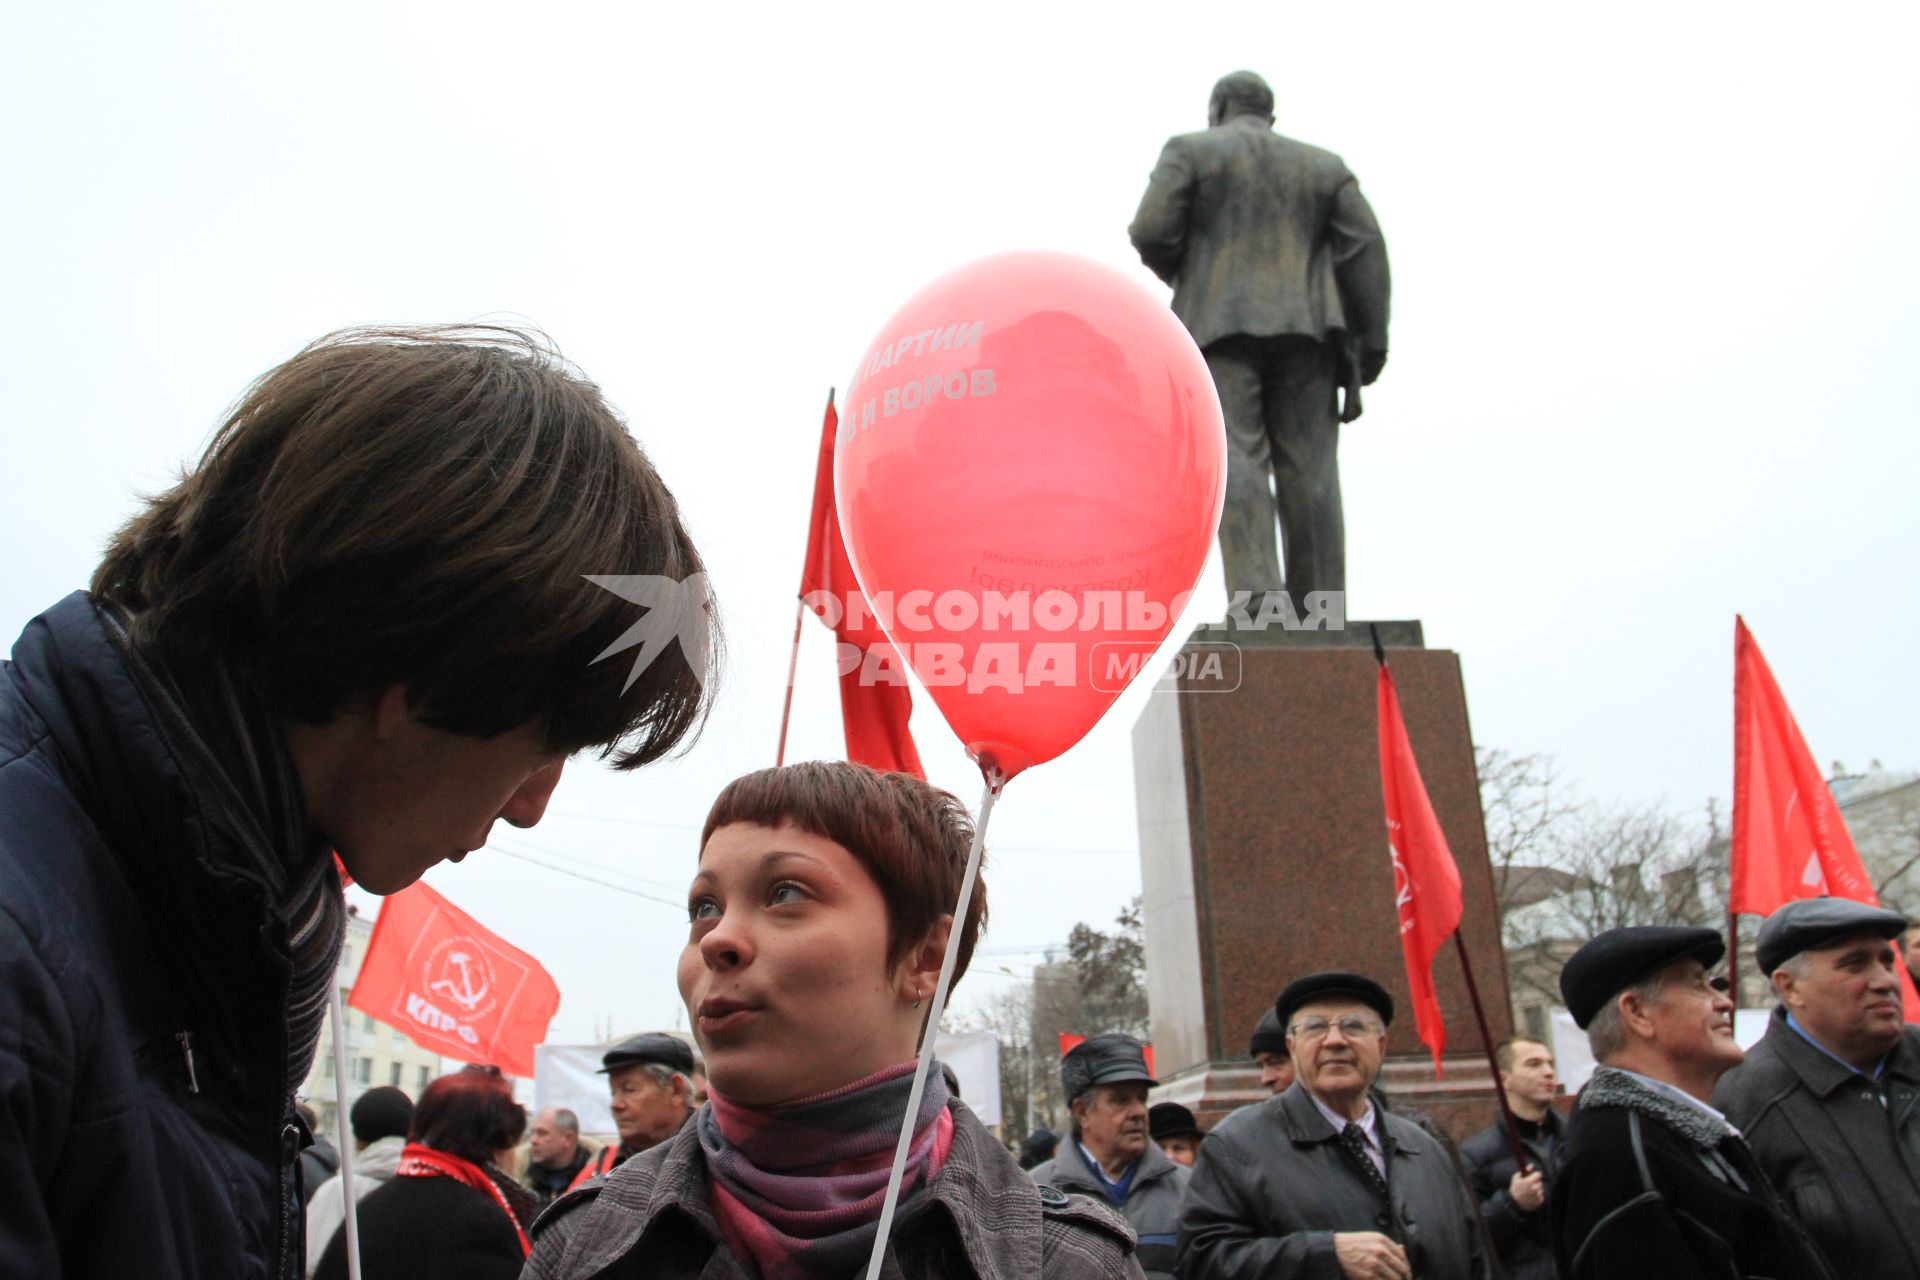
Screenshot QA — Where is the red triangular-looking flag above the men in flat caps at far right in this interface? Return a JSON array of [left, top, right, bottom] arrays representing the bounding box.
[[1728, 616, 1920, 1023]]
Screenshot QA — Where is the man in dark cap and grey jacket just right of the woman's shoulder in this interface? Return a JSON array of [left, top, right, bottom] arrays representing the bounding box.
[[1029, 1032, 1190, 1280]]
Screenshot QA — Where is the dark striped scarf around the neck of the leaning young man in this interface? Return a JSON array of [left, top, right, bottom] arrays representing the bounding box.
[[100, 606, 348, 1090]]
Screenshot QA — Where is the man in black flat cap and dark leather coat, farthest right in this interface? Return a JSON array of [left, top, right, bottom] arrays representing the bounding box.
[[1715, 898, 1920, 1276]]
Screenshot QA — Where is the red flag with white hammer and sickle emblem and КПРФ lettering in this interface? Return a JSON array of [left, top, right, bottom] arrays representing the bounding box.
[[348, 881, 561, 1075]]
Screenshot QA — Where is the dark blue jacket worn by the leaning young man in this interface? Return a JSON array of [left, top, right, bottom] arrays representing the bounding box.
[[0, 595, 303, 1280]]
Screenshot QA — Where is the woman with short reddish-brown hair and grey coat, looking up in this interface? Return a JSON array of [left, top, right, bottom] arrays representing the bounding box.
[[524, 762, 1140, 1280]]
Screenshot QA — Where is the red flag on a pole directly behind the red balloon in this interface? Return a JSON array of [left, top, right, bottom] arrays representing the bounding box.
[[801, 399, 927, 779]]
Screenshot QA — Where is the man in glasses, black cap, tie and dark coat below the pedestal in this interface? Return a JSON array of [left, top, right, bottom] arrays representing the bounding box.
[[1179, 973, 1488, 1280]]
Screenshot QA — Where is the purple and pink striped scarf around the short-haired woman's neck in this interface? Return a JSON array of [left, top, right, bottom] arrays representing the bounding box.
[[697, 1061, 954, 1280]]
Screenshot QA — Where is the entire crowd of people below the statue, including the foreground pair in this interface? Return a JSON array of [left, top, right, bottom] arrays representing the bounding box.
[[0, 330, 1920, 1280]]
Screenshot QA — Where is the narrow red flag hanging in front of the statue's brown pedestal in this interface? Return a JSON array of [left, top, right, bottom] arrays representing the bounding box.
[[1379, 662, 1463, 1079]]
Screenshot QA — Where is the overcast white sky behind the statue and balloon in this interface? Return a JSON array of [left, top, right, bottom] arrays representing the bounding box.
[[0, 0, 1920, 1040]]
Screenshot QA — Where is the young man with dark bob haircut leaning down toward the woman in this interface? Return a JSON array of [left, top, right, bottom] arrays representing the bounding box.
[[0, 328, 718, 1280]]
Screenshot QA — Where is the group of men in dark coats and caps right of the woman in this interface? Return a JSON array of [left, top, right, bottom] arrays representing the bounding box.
[[1025, 898, 1920, 1280]]
